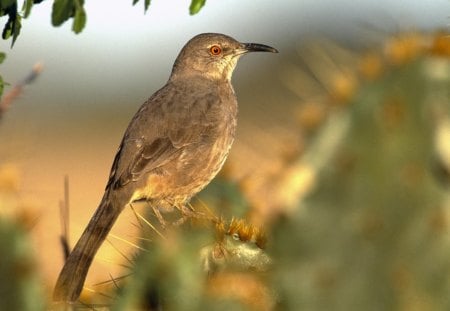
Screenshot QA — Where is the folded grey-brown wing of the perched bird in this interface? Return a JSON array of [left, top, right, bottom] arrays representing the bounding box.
[[107, 86, 218, 193]]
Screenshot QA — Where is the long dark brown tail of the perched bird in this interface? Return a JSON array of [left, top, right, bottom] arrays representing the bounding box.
[[53, 191, 124, 302]]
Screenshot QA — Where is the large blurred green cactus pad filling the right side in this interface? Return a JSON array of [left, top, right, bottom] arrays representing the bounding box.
[[273, 58, 450, 310]]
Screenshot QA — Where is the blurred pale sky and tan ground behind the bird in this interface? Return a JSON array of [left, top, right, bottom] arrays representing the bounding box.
[[0, 0, 450, 310]]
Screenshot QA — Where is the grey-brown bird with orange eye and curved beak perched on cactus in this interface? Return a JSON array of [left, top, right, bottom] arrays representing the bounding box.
[[53, 33, 278, 303]]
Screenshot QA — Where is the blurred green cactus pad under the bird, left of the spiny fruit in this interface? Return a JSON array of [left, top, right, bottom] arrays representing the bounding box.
[[112, 227, 208, 310]]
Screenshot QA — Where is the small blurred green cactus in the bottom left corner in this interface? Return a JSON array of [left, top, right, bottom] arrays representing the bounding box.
[[0, 219, 45, 311]]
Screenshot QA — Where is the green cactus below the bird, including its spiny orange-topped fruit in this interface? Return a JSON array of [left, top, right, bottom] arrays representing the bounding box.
[[111, 221, 271, 310]]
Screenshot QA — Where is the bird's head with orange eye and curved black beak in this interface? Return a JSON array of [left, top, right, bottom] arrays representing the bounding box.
[[171, 33, 278, 81]]
